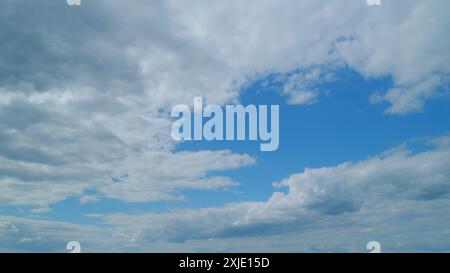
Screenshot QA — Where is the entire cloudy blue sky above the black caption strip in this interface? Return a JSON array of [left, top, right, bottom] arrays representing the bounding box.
[[0, 0, 450, 252]]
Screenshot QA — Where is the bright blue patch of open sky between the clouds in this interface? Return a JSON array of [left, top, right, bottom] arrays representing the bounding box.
[[177, 69, 450, 207]]
